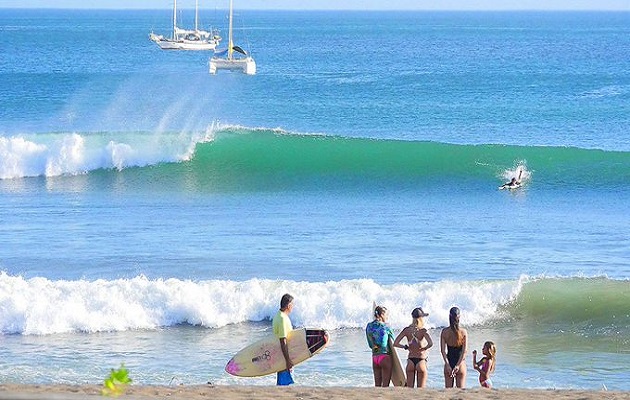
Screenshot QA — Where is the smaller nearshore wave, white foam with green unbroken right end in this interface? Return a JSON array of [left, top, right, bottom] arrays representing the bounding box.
[[0, 273, 630, 335]]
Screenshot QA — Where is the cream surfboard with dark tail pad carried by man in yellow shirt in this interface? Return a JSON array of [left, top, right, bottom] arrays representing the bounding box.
[[225, 328, 328, 377]]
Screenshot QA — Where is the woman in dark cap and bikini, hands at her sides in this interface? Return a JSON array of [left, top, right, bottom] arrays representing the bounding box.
[[394, 307, 433, 388]]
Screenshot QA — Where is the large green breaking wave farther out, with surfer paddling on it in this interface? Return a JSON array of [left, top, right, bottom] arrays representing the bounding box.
[[0, 124, 630, 190]]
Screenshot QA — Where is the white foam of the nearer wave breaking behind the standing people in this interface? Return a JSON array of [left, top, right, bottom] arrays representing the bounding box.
[[0, 273, 523, 335]]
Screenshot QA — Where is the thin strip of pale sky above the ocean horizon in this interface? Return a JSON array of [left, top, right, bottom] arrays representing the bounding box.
[[0, 0, 630, 11]]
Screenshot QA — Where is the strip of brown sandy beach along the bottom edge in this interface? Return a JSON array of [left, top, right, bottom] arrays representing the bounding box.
[[0, 384, 630, 400]]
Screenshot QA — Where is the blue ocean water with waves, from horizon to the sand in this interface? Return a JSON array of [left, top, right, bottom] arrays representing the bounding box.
[[0, 5, 630, 390]]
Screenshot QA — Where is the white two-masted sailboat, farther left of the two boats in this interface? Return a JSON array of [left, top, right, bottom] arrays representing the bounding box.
[[149, 0, 221, 50]]
